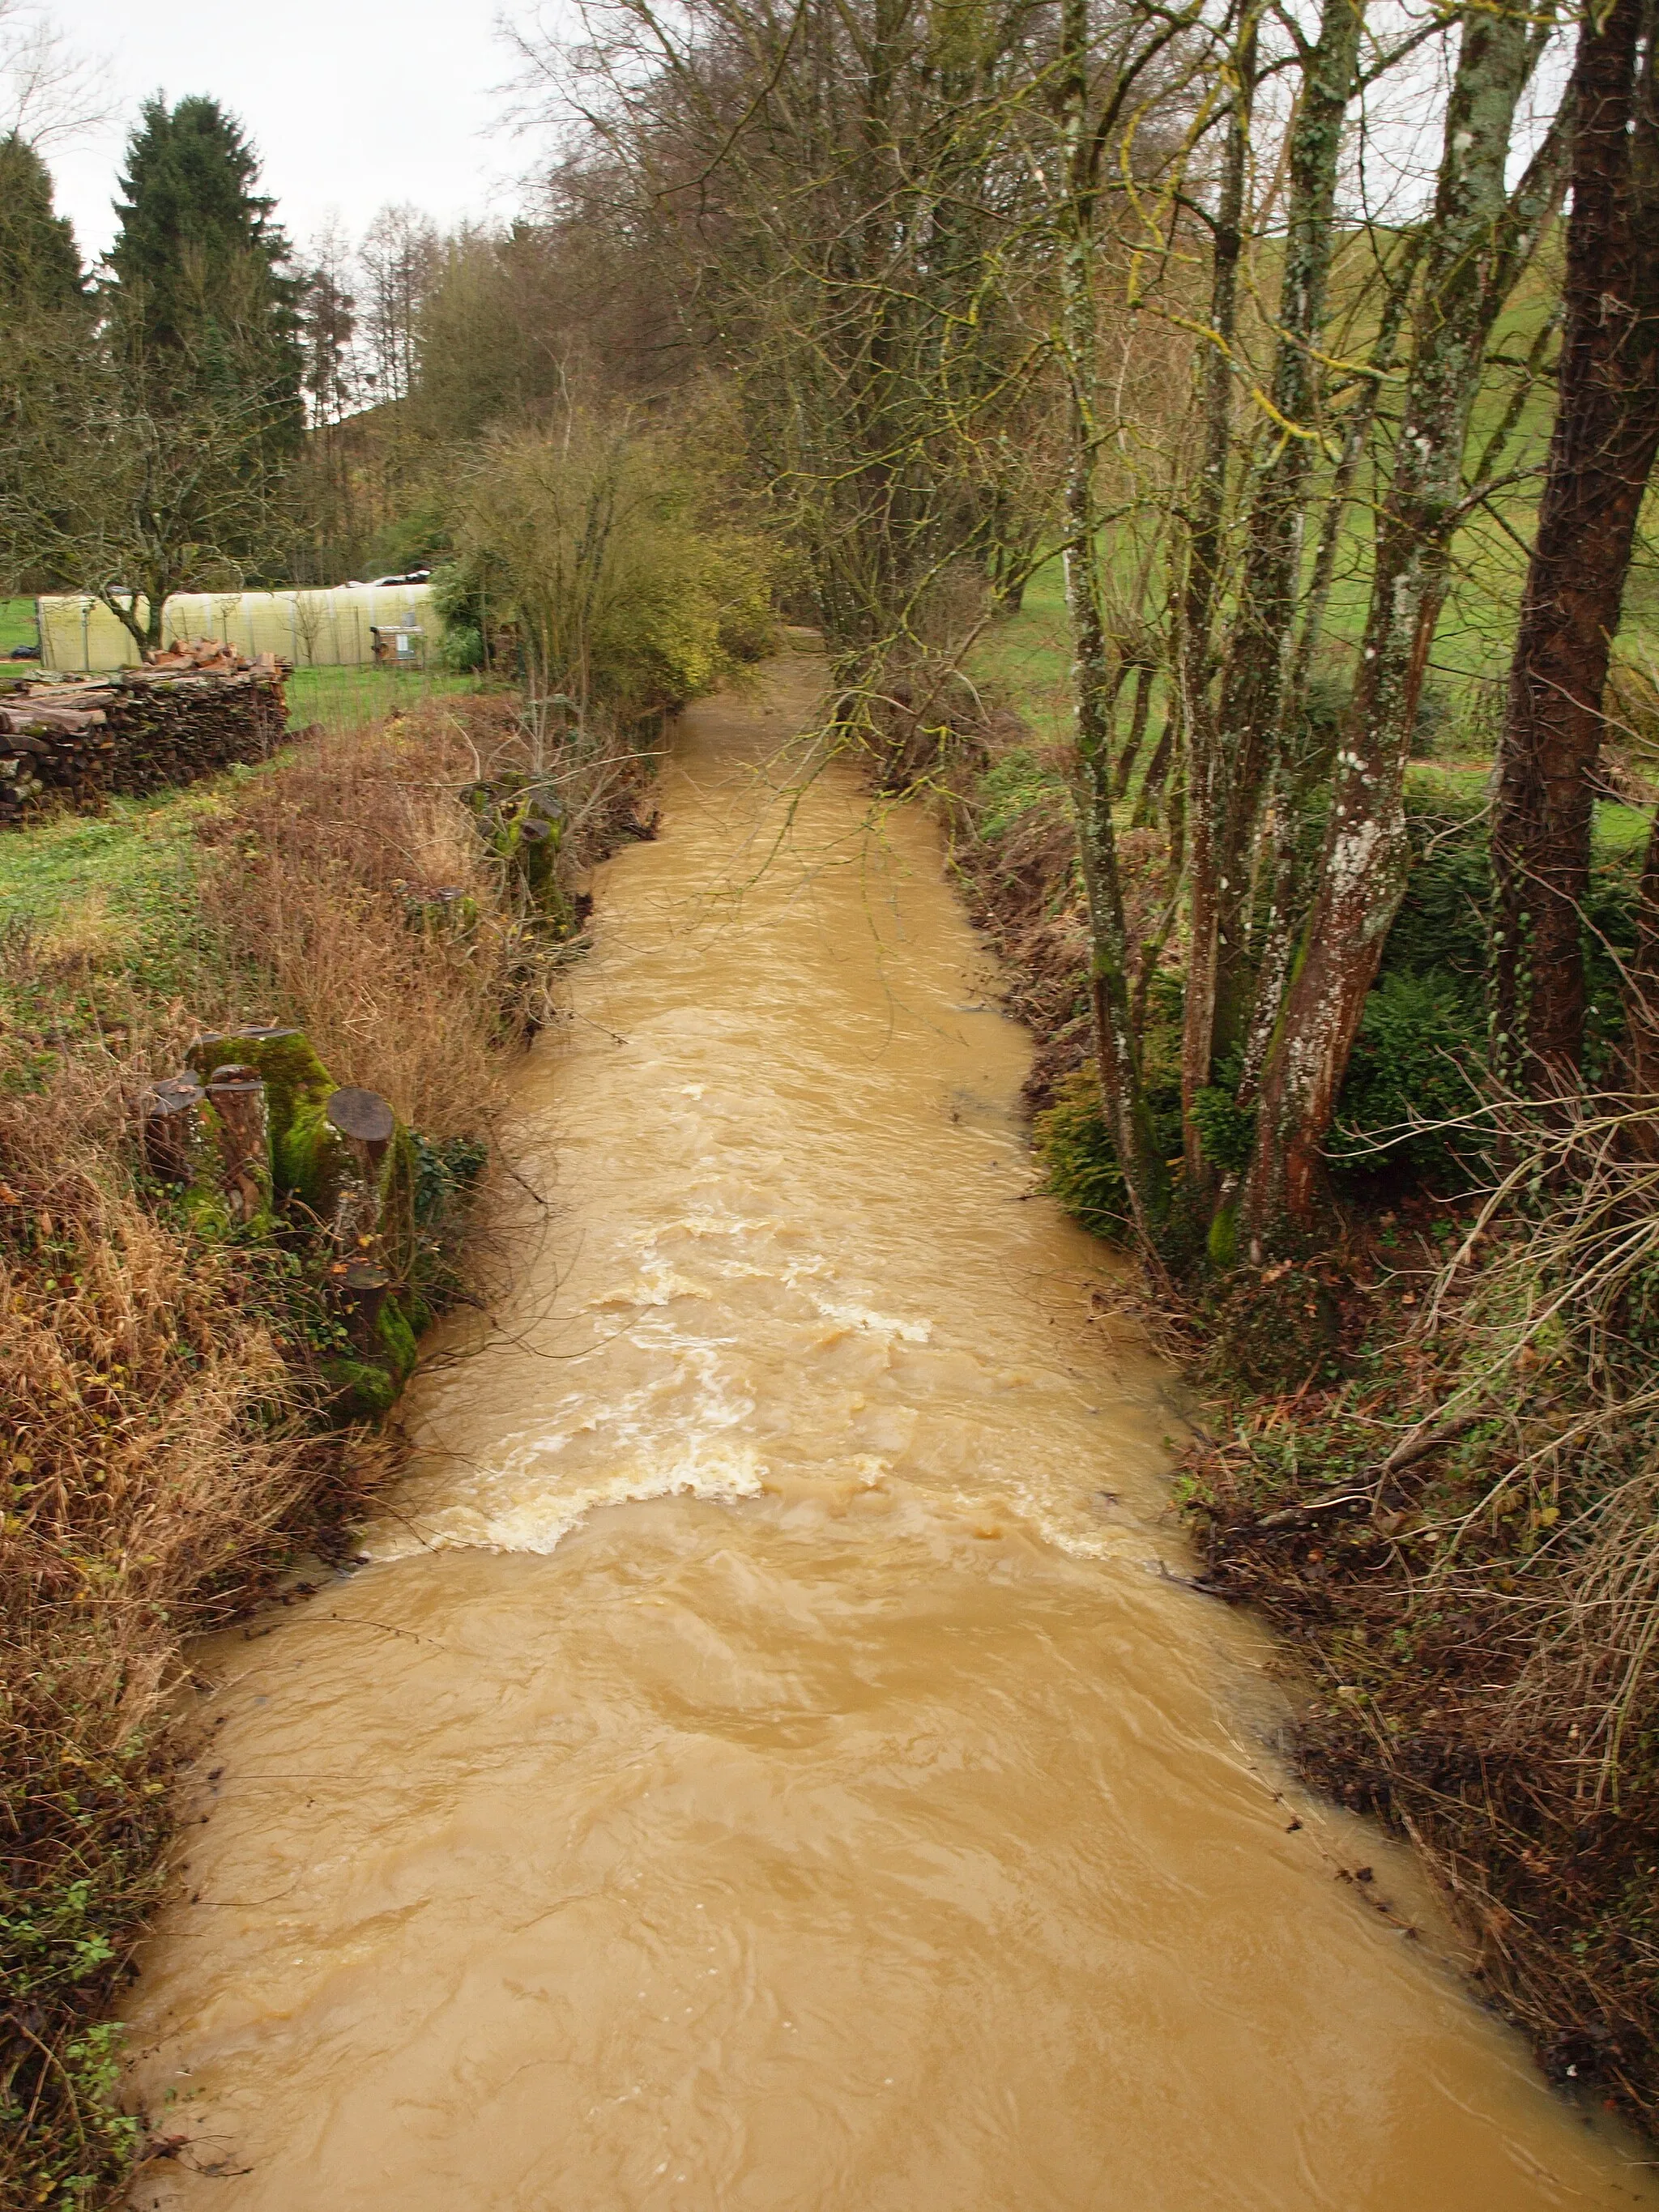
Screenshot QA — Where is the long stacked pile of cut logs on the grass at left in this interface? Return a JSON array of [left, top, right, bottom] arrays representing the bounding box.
[[0, 646, 288, 827]]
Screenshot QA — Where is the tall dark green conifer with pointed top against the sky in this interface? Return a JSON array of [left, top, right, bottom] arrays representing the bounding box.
[[109, 95, 303, 454]]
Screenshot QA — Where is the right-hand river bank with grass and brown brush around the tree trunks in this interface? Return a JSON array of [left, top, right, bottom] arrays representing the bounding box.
[[902, 637, 1659, 2130]]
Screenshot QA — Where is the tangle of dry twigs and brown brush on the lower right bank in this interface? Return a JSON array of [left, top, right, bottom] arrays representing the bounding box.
[[1190, 1099, 1659, 2130]]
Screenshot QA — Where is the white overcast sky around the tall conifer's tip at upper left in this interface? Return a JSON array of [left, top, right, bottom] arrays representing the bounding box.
[[46, 0, 552, 259]]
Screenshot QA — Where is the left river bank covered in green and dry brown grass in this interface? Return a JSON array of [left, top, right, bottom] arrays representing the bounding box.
[[0, 697, 663, 2208]]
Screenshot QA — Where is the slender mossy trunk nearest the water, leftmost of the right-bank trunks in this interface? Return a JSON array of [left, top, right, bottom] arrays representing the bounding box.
[[1060, 0, 1168, 1254]]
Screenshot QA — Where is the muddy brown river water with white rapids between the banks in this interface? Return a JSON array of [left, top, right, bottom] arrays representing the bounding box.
[[128, 659, 1659, 2212]]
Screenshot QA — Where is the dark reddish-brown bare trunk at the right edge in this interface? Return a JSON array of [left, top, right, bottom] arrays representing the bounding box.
[[1493, 0, 1659, 1095]]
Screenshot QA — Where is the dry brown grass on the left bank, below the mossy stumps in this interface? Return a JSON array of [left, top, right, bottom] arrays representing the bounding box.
[[0, 1044, 362, 2206]]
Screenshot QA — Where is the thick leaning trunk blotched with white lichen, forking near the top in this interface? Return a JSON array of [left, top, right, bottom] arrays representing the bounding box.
[[1245, 6, 1564, 1247]]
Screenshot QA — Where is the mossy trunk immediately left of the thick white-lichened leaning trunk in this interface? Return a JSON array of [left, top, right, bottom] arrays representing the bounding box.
[[1181, 0, 1365, 1195]]
